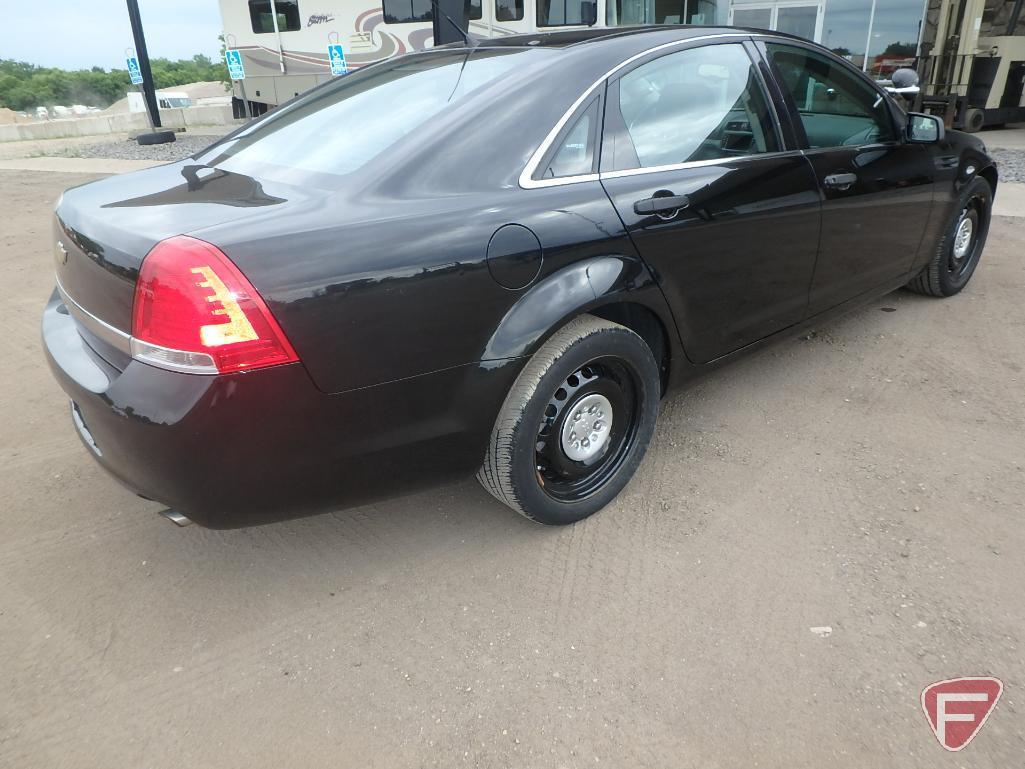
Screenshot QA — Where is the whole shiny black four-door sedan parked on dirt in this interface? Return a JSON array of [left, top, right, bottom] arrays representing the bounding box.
[[43, 27, 996, 527]]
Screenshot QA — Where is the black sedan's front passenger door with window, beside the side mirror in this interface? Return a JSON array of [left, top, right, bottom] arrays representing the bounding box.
[[763, 41, 934, 315]]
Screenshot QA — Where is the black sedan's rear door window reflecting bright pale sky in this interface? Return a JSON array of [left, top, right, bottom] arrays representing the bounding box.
[[602, 44, 779, 170]]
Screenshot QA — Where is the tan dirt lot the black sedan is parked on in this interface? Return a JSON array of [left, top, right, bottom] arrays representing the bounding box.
[[6, 171, 1025, 769]]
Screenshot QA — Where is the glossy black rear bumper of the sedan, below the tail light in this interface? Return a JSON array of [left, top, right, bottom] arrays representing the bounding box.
[[43, 292, 522, 528]]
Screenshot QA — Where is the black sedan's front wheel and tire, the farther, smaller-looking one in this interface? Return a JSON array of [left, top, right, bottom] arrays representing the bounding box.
[[907, 176, 993, 296]]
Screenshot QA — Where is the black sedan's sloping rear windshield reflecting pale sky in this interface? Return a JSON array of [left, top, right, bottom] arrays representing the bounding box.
[[198, 48, 551, 186]]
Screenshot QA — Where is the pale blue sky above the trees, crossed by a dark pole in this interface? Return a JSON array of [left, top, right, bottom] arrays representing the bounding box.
[[0, 0, 221, 70]]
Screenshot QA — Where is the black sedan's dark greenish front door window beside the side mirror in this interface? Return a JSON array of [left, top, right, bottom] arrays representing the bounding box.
[[768, 43, 895, 148]]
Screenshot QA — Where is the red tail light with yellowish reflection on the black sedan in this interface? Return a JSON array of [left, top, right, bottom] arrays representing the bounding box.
[[132, 235, 298, 373]]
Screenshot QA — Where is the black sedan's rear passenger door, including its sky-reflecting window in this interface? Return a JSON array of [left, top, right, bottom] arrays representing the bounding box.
[[600, 42, 820, 363]]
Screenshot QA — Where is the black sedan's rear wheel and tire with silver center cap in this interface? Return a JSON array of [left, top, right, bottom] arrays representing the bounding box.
[[477, 315, 661, 525]]
